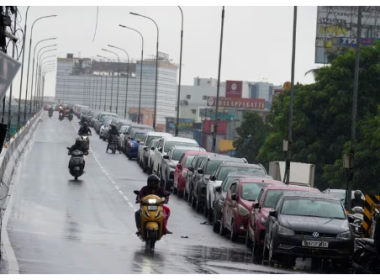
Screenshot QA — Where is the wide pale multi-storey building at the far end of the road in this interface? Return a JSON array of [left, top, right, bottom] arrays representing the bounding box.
[[55, 54, 178, 130]]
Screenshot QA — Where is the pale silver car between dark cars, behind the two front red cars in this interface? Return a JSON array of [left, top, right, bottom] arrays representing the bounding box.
[[204, 162, 268, 222]]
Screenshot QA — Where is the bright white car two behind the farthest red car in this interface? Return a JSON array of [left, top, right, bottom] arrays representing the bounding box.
[[152, 137, 199, 176]]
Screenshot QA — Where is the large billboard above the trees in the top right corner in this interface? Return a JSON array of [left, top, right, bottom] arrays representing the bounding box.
[[315, 5, 380, 64]]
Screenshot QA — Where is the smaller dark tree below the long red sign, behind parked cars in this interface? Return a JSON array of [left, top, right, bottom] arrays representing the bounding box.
[[234, 112, 270, 163]]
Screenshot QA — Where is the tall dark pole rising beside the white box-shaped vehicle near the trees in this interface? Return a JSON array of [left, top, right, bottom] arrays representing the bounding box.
[[284, 5, 298, 185]]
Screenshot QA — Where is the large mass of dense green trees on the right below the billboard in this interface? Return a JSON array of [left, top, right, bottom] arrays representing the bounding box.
[[258, 43, 380, 189]]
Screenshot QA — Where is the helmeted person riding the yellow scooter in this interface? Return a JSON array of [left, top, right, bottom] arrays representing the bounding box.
[[135, 175, 173, 235]]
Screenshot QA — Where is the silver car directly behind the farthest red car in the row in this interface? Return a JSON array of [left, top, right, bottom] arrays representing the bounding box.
[[161, 147, 206, 191]]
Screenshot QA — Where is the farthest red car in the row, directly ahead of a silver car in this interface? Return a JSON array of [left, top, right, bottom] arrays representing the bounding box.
[[173, 151, 207, 197]]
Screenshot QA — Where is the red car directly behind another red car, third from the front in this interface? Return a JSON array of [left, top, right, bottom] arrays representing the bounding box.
[[220, 177, 283, 241]]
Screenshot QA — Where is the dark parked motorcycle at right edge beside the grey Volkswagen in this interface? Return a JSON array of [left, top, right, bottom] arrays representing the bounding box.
[[352, 210, 380, 275]]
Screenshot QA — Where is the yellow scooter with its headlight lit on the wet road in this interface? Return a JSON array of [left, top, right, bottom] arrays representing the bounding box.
[[134, 191, 171, 252]]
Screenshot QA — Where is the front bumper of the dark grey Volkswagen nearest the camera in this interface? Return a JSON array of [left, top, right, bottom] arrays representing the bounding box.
[[274, 235, 354, 260]]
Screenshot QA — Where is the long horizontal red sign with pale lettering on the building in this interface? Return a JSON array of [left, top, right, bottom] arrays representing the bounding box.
[[207, 97, 265, 110]]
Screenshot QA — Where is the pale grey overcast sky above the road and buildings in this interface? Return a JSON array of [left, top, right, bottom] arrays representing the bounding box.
[[8, 5, 317, 96]]
